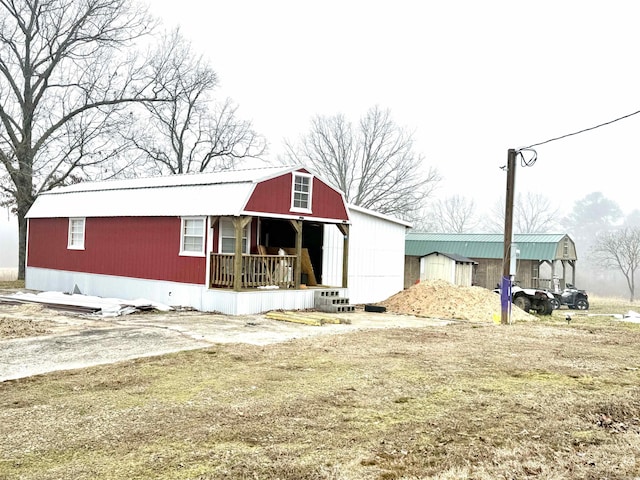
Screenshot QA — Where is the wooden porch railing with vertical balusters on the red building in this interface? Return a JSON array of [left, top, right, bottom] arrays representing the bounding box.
[[209, 253, 296, 288]]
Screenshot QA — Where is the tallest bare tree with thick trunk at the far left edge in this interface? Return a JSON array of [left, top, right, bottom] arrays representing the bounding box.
[[0, 0, 175, 278]]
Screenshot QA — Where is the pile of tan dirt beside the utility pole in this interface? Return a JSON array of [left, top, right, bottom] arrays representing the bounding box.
[[381, 280, 535, 322]]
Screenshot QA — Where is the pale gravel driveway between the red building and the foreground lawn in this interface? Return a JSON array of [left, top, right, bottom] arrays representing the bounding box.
[[0, 305, 450, 381]]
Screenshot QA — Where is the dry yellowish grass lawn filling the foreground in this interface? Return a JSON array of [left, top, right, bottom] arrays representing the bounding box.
[[0, 316, 640, 480]]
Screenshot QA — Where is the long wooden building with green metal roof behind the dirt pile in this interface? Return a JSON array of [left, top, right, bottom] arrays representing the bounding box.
[[405, 232, 578, 288]]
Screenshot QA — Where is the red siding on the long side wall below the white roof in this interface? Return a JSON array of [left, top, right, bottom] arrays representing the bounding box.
[[27, 217, 206, 284]]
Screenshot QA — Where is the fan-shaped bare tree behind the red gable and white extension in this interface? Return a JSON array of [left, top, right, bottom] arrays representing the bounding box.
[[285, 107, 440, 219]]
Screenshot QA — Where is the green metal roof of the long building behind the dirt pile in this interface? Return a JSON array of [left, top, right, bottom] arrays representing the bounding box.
[[405, 232, 576, 260]]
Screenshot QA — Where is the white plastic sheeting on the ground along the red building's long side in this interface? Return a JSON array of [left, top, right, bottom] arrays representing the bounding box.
[[0, 292, 172, 317]]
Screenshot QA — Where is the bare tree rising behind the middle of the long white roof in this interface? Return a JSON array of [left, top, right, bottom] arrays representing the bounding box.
[[127, 30, 266, 174]]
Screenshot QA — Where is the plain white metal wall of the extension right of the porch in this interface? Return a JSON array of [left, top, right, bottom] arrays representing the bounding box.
[[322, 209, 406, 304]]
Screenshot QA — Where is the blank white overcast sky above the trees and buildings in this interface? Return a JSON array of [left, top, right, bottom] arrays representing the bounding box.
[[150, 0, 640, 215]]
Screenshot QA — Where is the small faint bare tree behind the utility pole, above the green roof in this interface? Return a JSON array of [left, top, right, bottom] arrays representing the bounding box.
[[486, 192, 560, 233]]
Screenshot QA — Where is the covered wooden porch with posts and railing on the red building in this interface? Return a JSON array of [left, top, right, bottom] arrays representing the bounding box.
[[207, 215, 349, 292]]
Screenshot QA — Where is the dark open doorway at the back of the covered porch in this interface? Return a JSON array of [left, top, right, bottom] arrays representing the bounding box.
[[258, 218, 324, 285]]
